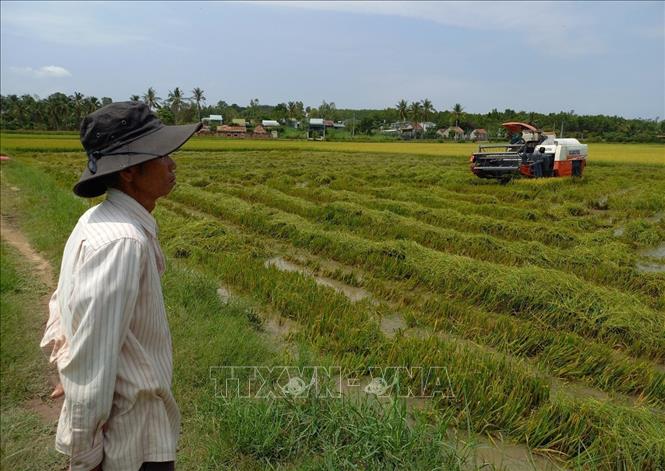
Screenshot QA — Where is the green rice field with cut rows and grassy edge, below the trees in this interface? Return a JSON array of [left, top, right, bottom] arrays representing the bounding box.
[[2, 135, 665, 470]]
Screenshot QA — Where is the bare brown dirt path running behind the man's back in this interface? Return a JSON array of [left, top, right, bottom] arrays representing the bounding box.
[[0, 216, 63, 423]]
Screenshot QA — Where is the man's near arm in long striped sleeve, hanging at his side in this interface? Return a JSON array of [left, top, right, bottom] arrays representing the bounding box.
[[59, 238, 146, 471]]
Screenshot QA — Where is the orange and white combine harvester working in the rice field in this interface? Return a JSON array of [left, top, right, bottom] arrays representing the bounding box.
[[470, 122, 588, 183]]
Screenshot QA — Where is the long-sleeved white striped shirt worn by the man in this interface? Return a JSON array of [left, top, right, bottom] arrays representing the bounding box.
[[41, 189, 180, 471]]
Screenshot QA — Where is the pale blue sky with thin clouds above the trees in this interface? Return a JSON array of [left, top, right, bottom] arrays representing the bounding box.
[[0, 0, 665, 119]]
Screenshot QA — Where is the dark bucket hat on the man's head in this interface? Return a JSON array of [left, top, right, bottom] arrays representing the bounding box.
[[74, 101, 201, 198]]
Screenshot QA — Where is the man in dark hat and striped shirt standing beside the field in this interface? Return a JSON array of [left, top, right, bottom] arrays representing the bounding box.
[[41, 102, 200, 471]]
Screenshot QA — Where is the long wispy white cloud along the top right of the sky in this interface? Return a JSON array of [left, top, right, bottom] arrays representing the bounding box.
[[257, 1, 606, 56]]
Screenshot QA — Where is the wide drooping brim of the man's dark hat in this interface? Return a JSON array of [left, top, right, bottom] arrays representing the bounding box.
[[74, 123, 201, 198]]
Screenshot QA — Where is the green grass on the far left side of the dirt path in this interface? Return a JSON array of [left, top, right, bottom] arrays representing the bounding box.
[[0, 242, 65, 470]]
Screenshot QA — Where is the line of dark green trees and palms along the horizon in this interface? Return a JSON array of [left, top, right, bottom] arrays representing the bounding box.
[[0, 87, 665, 142]]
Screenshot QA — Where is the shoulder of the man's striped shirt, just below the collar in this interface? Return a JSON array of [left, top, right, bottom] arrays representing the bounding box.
[[78, 202, 148, 249]]
